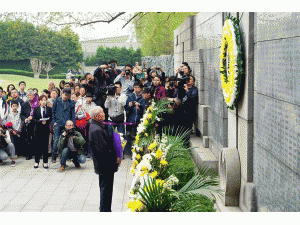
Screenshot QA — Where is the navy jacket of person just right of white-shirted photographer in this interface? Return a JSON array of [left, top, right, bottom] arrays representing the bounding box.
[[124, 93, 145, 123]]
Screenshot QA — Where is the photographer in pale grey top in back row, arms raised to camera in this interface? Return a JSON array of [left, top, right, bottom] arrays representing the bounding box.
[[114, 64, 134, 96]]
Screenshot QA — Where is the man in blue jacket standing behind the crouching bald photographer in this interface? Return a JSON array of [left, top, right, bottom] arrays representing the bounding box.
[[52, 88, 76, 163]]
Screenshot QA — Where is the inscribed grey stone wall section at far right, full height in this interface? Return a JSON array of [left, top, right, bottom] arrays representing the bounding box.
[[254, 13, 300, 211]]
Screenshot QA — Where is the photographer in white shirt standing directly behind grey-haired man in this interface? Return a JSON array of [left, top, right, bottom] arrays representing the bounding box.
[[104, 82, 126, 134]]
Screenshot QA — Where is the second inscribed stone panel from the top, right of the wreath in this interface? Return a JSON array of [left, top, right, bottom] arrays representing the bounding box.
[[255, 37, 300, 106]]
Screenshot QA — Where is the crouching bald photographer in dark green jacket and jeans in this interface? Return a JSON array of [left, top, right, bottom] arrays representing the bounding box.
[[57, 120, 86, 172]]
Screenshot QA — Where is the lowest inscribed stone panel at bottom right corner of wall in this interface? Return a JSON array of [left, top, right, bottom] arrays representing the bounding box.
[[253, 137, 300, 212]]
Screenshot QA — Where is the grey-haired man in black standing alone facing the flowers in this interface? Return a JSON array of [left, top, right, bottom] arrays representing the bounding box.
[[89, 106, 121, 212]]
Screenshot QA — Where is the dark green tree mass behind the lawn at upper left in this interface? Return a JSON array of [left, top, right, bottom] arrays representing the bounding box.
[[0, 20, 83, 72]]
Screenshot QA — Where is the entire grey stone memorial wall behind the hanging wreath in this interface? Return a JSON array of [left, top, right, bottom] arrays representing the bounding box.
[[174, 12, 300, 211]]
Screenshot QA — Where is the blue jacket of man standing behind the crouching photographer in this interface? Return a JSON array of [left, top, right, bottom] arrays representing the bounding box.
[[52, 97, 76, 127]]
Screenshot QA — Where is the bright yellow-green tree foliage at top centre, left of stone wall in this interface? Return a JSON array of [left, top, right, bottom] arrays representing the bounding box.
[[133, 12, 197, 56]]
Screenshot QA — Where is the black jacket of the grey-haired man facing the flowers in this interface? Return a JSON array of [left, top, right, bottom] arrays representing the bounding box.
[[89, 120, 118, 175]]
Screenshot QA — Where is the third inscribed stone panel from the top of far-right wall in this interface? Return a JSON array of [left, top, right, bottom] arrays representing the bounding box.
[[254, 94, 300, 174]]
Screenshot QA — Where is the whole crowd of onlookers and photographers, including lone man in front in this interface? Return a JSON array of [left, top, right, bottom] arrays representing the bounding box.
[[0, 60, 198, 211]]
